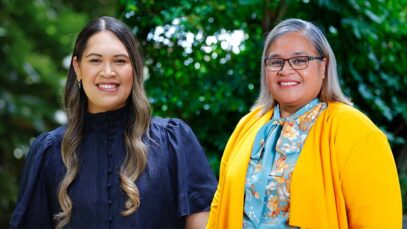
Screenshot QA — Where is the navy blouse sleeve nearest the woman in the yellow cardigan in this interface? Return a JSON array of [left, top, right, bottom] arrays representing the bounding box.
[[167, 119, 217, 217]]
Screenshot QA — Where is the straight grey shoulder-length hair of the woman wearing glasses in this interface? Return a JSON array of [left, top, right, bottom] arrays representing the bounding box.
[[252, 18, 352, 115]]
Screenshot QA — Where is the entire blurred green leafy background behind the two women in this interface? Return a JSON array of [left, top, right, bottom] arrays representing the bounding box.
[[0, 0, 407, 225]]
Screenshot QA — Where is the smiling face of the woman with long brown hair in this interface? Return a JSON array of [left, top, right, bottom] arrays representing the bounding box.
[[73, 31, 134, 113]]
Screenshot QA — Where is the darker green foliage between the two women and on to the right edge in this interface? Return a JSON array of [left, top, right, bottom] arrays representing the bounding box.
[[121, 0, 407, 177]]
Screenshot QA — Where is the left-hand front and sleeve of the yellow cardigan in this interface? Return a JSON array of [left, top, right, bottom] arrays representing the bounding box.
[[207, 110, 271, 229]]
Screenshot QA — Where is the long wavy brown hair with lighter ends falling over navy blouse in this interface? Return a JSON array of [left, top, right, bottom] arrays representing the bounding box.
[[54, 16, 151, 228]]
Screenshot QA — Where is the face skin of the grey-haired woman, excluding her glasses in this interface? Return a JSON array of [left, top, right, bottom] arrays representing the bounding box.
[[266, 32, 327, 117]]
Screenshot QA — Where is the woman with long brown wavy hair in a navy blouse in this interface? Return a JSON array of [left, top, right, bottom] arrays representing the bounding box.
[[10, 17, 216, 228]]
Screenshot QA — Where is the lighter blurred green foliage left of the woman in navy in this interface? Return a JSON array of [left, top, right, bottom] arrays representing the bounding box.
[[0, 0, 115, 225]]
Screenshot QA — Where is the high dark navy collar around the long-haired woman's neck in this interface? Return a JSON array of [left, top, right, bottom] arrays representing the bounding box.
[[85, 105, 130, 132]]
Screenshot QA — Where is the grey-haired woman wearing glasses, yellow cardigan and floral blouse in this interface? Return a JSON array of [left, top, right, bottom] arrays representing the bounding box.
[[208, 19, 402, 229]]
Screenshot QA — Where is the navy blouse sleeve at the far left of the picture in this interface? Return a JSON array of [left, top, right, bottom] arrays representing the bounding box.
[[10, 133, 54, 228]]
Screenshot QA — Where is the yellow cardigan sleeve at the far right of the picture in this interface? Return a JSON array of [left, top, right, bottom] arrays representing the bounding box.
[[341, 131, 402, 228]]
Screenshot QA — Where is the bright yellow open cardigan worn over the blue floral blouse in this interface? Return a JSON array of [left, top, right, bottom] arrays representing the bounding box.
[[207, 102, 402, 229]]
